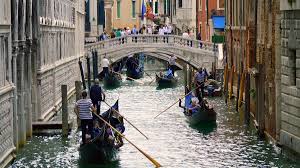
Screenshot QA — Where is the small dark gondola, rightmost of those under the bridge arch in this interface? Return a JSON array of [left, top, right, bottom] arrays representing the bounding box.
[[156, 69, 178, 87]]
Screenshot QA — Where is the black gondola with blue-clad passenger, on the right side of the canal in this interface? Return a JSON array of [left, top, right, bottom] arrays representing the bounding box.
[[179, 92, 217, 125]]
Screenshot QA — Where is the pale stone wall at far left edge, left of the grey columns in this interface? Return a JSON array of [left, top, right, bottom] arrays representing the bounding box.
[[0, 1, 16, 167]]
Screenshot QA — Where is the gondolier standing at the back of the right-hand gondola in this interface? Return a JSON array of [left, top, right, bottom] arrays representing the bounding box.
[[194, 68, 206, 102]]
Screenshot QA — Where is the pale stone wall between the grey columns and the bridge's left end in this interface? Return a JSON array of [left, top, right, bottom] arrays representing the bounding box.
[[35, 0, 84, 120]]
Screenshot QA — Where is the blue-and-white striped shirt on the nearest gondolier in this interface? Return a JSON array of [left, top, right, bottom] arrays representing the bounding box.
[[75, 99, 93, 120]]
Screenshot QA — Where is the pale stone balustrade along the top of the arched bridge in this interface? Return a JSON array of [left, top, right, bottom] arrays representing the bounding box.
[[85, 35, 214, 52]]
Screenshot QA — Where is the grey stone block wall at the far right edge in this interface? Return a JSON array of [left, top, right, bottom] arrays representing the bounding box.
[[280, 1, 300, 153]]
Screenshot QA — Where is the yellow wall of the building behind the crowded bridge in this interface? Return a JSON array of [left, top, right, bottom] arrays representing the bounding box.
[[112, 0, 142, 29]]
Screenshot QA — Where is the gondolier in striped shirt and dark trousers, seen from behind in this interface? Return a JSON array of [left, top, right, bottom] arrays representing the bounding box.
[[75, 90, 96, 144]]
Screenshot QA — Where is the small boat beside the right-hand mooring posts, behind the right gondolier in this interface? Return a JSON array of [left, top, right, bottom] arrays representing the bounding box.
[[204, 79, 222, 97]]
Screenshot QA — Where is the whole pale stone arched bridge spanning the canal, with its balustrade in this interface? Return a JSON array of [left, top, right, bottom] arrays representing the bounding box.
[[85, 35, 218, 69]]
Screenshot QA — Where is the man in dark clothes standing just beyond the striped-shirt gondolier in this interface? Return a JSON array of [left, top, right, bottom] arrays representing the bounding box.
[[90, 79, 105, 118]]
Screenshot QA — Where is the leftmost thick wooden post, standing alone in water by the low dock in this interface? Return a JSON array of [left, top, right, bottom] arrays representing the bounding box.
[[61, 85, 69, 137]]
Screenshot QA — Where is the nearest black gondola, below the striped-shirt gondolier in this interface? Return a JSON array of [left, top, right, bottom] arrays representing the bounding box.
[[79, 101, 125, 163]]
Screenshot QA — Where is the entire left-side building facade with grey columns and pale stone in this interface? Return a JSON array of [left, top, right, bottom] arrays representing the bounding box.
[[0, 0, 85, 167]]
